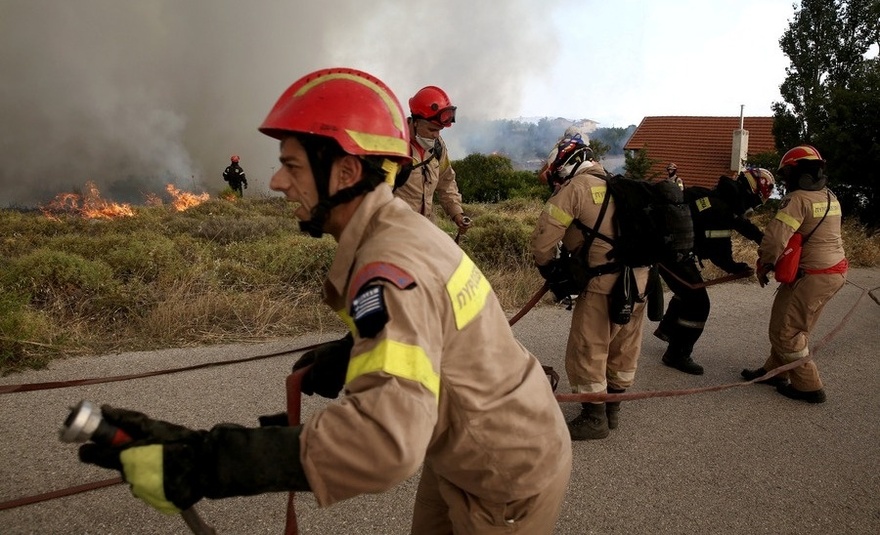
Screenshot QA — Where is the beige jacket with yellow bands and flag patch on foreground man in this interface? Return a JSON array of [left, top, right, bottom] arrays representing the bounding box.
[[300, 184, 571, 506]]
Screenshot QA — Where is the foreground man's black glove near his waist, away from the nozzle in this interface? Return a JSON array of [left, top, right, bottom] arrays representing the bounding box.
[[293, 333, 354, 399]]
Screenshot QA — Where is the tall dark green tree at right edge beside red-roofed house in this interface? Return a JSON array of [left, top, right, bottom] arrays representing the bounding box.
[[773, 0, 880, 226]]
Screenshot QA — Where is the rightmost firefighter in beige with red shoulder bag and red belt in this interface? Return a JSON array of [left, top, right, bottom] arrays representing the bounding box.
[[742, 145, 848, 403]]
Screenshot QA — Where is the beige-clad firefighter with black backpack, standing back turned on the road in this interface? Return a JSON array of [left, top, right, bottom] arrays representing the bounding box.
[[531, 135, 648, 440]]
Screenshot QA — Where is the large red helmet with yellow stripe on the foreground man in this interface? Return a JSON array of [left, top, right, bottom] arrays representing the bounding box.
[[259, 68, 412, 163]]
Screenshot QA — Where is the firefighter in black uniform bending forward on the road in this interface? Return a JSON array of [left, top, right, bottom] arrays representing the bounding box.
[[654, 168, 774, 375]]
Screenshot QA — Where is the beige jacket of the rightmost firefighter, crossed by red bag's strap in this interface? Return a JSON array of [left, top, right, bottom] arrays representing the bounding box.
[[758, 188, 845, 269]]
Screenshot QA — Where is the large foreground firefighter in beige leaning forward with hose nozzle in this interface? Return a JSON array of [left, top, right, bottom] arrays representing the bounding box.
[[80, 69, 571, 534]]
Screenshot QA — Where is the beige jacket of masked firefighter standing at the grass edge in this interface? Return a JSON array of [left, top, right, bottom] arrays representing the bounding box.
[[394, 137, 464, 221]]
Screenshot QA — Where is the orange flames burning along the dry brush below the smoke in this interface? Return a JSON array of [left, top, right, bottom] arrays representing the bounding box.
[[40, 181, 211, 221]]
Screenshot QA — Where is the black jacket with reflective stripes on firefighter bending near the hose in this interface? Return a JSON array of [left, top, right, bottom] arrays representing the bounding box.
[[684, 177, 764, 273]]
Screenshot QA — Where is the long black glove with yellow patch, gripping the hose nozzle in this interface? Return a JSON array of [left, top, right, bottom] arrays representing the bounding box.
[[79, 405, 311, 514]]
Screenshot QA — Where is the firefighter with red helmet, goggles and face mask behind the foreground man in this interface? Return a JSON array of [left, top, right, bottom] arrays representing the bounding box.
[[394, 85, 471, 234]]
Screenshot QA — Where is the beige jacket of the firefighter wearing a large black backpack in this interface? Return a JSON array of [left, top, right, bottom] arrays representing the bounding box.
[[531, 162, 648, 295]]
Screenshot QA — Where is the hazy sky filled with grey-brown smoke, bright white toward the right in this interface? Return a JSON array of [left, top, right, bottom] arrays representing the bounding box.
[[0, 0, 793, 206]]
